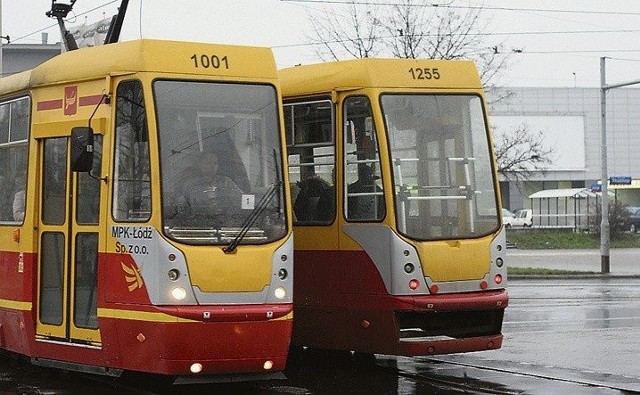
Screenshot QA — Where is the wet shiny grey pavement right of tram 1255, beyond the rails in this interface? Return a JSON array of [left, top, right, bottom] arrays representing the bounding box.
[[442, 278, 640, 393]]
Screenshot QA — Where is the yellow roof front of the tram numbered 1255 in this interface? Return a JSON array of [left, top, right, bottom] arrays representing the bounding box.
[[278, 58, 482, 96]]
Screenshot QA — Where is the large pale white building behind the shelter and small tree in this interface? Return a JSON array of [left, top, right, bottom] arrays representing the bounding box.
[[489, 87, 640, 210]]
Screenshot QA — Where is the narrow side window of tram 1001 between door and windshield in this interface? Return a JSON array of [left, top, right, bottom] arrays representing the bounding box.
[[113, 81, 151, 222]]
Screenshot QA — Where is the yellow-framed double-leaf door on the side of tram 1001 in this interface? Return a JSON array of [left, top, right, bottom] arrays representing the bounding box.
[[36, 136, 102, 345]]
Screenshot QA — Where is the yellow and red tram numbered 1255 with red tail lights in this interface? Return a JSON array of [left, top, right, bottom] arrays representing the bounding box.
[[279, 59, 508, 356]]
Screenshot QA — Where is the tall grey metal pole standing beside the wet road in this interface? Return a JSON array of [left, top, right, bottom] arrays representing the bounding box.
[[600, 57, 610, 274]]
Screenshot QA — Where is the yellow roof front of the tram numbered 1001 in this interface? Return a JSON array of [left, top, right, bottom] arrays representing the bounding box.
[[0, 39, 277, 95]]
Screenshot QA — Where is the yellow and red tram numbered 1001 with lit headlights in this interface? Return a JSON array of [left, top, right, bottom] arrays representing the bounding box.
[[0, 40, 293, 377]]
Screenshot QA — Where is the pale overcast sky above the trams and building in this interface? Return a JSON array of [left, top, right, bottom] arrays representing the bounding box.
[[0, 0, 640, 87]]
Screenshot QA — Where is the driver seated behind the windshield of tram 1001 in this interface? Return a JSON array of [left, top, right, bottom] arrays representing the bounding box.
[[177, 151, 242, 227]]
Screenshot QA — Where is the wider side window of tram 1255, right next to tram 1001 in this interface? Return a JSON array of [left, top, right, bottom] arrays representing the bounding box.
[[284, 100, 336, 225]]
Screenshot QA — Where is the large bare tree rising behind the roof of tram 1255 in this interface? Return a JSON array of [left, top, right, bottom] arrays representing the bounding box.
[[309, 0, 511, 89]]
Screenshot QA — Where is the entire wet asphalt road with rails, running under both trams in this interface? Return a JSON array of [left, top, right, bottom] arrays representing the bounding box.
[[0, 251, 640, 394]]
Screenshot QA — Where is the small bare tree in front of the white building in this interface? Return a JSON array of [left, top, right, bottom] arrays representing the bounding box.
[[494, 123, 555, 181]]
